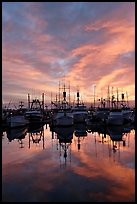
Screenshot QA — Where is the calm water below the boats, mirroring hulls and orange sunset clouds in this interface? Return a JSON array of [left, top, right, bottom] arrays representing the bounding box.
[[2, 125, 135, 202]]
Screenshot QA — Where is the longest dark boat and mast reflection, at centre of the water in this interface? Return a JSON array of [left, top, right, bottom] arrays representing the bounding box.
[[52, 126, 74, 166]]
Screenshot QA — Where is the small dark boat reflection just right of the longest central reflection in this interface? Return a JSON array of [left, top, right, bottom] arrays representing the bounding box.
[[74, 123, 87, 150]]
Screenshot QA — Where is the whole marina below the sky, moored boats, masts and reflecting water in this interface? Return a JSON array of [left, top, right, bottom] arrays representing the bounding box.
[[2, 80, 135, 202]]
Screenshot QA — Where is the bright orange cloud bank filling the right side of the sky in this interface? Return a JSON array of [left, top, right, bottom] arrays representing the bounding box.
[[64, 15, 135, 99]]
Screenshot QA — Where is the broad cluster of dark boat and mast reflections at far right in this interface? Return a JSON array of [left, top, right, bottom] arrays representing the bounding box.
[[87, 124, 134, 162]]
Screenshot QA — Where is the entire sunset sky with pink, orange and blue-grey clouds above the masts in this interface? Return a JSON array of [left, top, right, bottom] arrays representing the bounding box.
[[2, 2, 135, 107]]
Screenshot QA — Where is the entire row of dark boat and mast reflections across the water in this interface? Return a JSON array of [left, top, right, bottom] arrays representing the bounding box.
[[4, 120, 134, 165]]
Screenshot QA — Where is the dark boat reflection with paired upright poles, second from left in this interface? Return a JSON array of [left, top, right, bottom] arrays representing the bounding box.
[[28, 124, 44, 149]]
